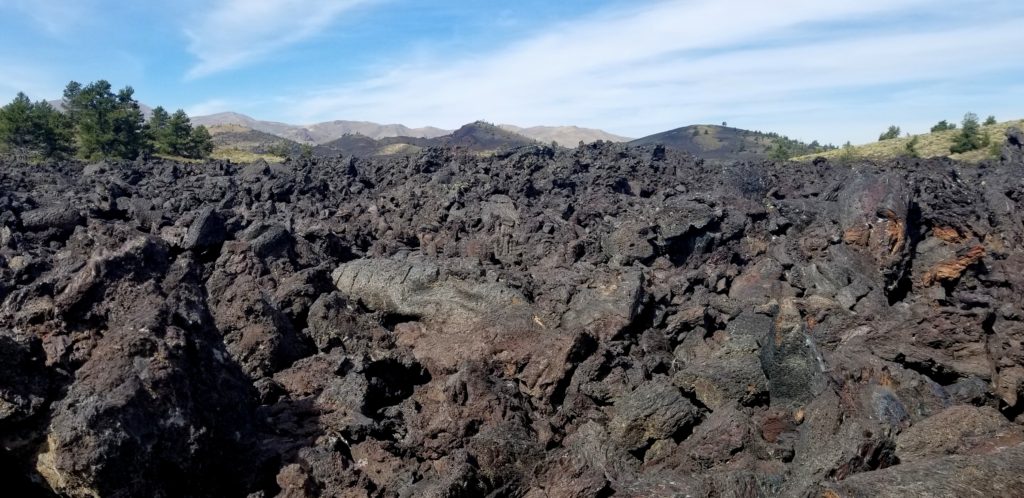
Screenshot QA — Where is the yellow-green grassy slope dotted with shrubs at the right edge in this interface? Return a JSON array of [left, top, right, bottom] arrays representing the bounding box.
[[794, 120, 1024, 162]]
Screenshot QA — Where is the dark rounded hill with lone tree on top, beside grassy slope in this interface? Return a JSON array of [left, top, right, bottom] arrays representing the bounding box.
[[630, 125, 827, 161]]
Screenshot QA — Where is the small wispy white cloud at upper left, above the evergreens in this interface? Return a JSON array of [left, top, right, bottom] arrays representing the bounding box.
[[185, 0, 377, 79]]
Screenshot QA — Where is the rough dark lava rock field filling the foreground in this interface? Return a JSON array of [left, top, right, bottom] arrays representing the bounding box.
[[0, 131, 1024, 498]]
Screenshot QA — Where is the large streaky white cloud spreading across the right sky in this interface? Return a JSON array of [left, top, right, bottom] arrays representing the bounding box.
[[284, 0, 1024, 139]]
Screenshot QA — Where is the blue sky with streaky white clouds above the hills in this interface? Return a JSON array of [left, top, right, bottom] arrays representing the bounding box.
[[0, 0, 1024, 144]]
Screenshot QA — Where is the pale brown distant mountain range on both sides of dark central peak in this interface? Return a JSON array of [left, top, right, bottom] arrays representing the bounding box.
[[191, 113, 629, 147]]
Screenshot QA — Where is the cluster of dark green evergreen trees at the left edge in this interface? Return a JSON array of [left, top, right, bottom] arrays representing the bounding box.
[[0, 80, 213, 160]]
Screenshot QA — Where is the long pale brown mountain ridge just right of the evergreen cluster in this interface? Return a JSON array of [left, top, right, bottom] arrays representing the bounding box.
[[191, 113, 451, 143]]
